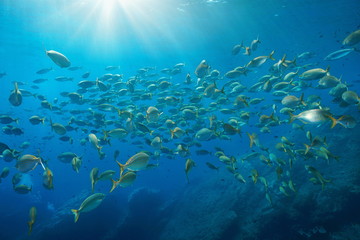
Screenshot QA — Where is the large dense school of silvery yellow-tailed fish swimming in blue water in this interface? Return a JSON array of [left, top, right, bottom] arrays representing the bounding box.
[[0, 30, 360, 234]]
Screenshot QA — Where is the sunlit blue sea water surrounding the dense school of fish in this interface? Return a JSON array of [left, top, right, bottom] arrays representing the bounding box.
[[0, 0, 360, 240]]
